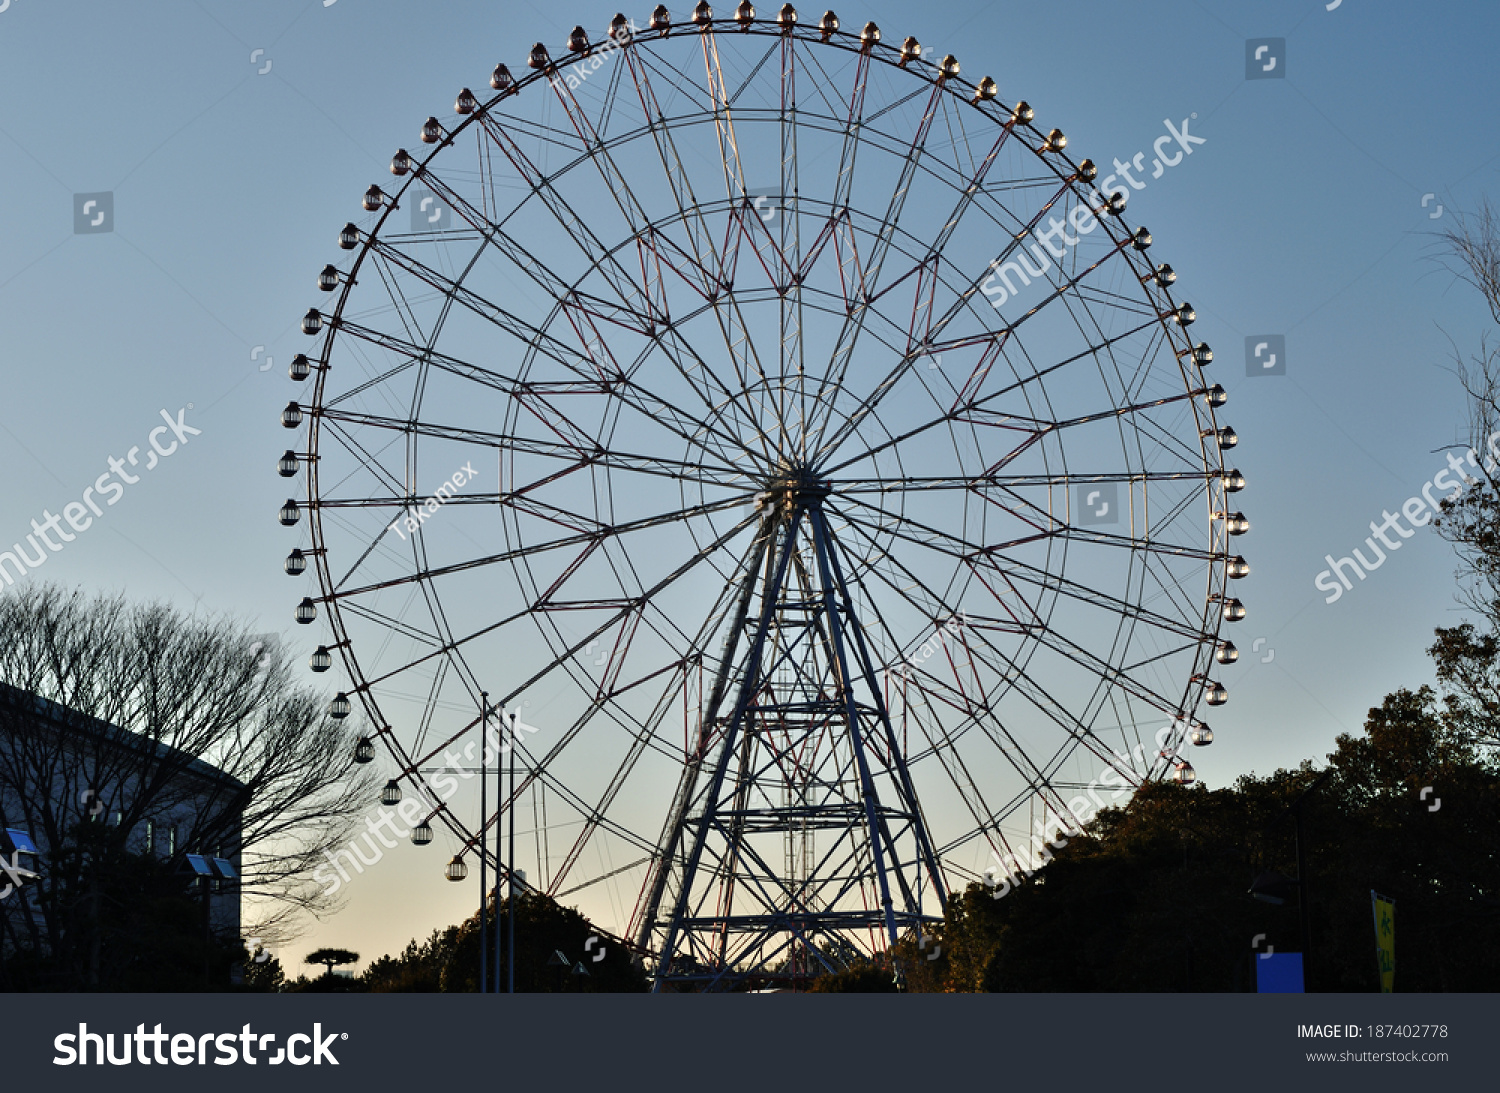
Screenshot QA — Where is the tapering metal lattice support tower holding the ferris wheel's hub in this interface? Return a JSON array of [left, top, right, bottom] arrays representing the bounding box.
[[635, 466, 947, 991]]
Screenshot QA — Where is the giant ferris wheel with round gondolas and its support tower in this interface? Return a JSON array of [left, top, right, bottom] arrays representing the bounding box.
[[281, 3, 1250, 990]]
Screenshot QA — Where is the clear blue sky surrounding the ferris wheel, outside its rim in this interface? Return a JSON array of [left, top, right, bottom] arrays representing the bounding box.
[[0, 0, 1500, 963]]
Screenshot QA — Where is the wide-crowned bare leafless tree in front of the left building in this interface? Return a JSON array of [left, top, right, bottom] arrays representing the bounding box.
[[0, 583, 377, 981]]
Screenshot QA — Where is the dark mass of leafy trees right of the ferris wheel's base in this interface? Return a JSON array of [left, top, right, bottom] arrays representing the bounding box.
[[903, 688, 1500, 993]]
